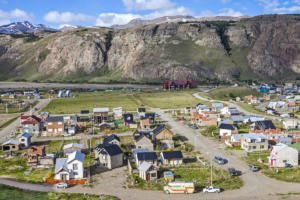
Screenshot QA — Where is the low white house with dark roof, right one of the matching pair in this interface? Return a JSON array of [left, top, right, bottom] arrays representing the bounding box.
[[160, 151, 183, 166]]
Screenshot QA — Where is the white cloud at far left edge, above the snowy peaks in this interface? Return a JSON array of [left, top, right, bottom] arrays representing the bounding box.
[[0, 8, 34, 25]]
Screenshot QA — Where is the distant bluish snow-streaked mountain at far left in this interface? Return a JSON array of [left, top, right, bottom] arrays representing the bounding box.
[[0, 21, 58, 34]]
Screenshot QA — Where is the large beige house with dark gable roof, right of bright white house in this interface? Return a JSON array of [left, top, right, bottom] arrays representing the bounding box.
[[95, 144, 123, 169]]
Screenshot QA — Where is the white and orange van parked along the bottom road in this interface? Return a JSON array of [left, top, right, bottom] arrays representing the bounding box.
[[164, 181, 195, 194]]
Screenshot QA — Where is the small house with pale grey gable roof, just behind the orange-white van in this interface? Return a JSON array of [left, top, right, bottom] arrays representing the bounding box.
[[138, 162, 157, 182]]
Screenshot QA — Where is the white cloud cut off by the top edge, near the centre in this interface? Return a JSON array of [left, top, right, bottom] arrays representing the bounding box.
[[122, 0, 175, 10]]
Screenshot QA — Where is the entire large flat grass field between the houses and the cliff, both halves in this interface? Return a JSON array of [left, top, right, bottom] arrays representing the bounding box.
[[43, 90, 209, 114]]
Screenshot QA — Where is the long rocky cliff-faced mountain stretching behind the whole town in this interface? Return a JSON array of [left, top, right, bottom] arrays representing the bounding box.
[[0, 15, 300, 83]]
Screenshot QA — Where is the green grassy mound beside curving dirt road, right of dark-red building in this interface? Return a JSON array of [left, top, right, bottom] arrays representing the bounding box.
[[207, 87, 261, 101]]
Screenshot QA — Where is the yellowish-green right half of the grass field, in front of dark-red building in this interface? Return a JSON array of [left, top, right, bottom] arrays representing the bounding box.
[[135, 90, 207, 109]]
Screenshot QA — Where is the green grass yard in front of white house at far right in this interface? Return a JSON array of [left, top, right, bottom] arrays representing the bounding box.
[[245, 152, 300, 183]]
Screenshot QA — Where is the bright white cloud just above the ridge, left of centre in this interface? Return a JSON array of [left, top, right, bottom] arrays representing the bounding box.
[[95, 13, 141, 27]]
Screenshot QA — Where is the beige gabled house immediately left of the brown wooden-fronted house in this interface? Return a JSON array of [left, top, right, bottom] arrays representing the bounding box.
[[133, 131, 154, 151]]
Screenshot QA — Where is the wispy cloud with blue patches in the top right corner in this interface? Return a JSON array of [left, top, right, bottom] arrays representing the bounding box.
[[258, 0, 300, 14]]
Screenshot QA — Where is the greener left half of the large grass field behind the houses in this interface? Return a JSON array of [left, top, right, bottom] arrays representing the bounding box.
[[43, 91, 138, 114]]
